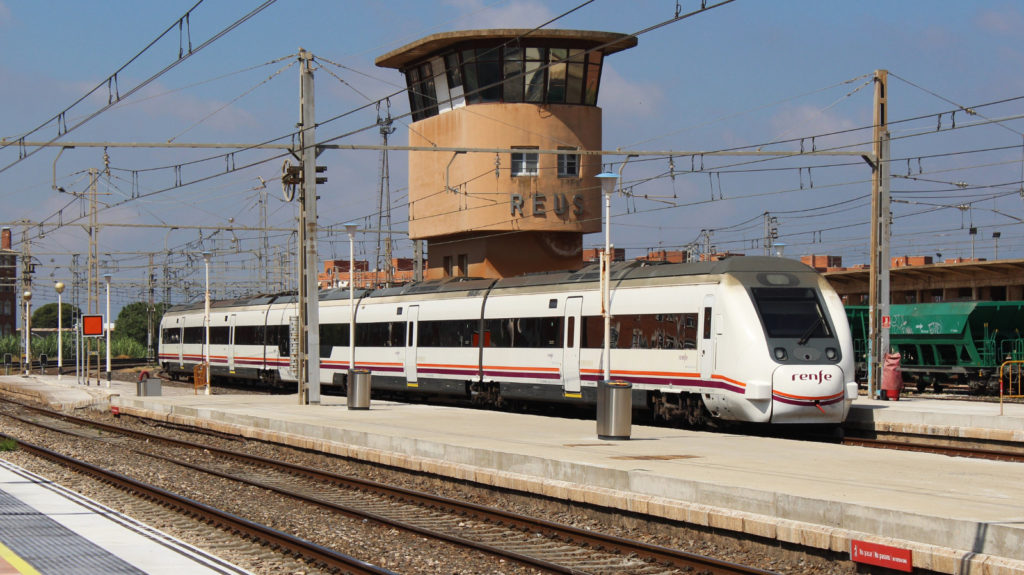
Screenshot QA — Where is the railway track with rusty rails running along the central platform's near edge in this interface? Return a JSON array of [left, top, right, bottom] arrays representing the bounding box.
[[4, 399, 768, 575]]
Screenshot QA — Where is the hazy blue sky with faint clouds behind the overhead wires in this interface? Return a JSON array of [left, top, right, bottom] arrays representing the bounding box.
[[0, 0, 1024, 310]]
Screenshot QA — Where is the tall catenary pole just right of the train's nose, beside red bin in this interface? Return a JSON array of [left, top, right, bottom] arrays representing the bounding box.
[[867, 70, 891, 398]]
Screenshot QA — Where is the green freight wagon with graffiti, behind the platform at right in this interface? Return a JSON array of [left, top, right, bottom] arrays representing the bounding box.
[[846, 302, 1024, 393]]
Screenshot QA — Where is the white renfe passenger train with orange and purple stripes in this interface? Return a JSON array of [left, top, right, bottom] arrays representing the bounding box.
[[160, 257, 857, 426]]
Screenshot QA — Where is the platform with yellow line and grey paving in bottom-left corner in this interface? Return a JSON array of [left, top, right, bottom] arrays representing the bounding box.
[[0, 459, 248, 575]]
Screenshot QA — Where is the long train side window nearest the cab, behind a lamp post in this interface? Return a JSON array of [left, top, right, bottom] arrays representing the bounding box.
[[580, 313, 697, 349]]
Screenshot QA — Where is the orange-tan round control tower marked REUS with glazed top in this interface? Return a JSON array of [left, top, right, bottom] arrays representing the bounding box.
[[376, 30, 637, 278]]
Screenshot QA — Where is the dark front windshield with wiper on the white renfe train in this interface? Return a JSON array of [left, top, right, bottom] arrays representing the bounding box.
[[751, 288, 833, 345]]
